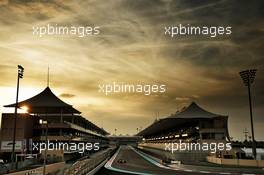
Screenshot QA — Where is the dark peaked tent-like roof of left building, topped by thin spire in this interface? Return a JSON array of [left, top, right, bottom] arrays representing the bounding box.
[[4, 87, 81, 114]]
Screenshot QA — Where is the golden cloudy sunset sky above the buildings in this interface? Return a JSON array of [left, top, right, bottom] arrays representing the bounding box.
[[0, 0, 264, 140]]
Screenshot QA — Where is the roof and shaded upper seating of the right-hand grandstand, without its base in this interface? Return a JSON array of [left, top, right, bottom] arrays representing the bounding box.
[[137, 102, 229, 142]]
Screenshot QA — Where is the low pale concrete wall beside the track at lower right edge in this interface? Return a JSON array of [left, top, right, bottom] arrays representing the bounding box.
[[206, 156, 264, 167]]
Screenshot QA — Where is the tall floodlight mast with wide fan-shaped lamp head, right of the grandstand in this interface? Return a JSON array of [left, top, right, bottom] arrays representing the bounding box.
[[239, 69, 257, 159]]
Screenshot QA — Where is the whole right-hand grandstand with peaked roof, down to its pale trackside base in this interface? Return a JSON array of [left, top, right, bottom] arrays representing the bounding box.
[[137, 102, 230, 161]]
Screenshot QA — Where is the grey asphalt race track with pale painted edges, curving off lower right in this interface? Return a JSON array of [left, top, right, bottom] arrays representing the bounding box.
[[101, 146, 264, 175]]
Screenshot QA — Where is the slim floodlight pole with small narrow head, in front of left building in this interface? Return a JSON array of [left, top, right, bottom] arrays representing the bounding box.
[[12, 65, 24, 168]]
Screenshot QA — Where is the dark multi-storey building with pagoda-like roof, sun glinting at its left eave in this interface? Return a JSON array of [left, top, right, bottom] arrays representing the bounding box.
[[0, 87, 108, 161]]
